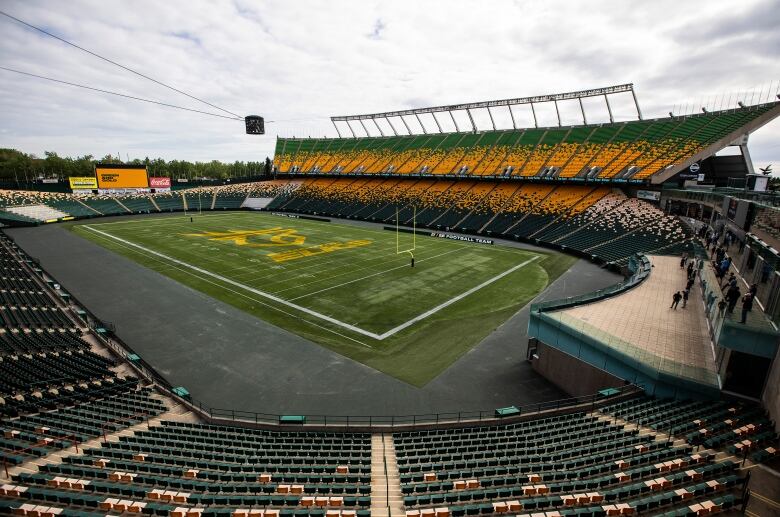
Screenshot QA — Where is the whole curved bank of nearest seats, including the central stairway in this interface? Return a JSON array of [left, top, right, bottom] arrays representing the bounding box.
[[0, 398, 768, 517]]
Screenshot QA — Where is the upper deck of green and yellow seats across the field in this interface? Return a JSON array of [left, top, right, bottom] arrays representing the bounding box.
[[275, 103, 773, 180]]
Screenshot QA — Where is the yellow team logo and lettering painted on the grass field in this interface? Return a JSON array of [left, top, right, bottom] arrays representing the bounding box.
[[184, 226, 371, 263]]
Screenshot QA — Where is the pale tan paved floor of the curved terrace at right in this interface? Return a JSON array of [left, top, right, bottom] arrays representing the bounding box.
[[553, 255, 717, 386]]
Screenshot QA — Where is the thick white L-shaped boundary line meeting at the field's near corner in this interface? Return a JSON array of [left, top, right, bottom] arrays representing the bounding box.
[[83, 224, 539, 341]]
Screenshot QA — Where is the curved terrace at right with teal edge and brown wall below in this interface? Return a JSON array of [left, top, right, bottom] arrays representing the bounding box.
[[528, 256, 720, 399]]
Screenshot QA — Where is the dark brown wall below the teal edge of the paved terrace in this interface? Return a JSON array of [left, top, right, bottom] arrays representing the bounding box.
[[532, 343, 625, 397]]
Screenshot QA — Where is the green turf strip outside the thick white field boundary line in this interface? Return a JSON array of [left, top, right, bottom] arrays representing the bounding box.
[[69, 212, 576, 386]]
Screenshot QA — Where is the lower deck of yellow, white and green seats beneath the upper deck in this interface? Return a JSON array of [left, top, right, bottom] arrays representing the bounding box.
[[268, 177, 690, 264]]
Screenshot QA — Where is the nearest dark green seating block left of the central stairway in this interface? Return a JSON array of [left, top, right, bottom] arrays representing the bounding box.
[[0, 419, 371, 517]]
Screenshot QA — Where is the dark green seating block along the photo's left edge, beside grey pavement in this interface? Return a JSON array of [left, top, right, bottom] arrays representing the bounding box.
[[0, 232, 169, 474]]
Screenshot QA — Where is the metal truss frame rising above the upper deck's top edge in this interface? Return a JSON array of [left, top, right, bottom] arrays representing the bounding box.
[[330, 83, 642, 138]]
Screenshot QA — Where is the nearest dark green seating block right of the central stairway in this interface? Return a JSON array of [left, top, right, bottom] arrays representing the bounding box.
[[394, 408, 742, 517]]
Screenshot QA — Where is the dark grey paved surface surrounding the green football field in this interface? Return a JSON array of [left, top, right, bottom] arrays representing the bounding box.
[[4, 219, 621, 416]]
